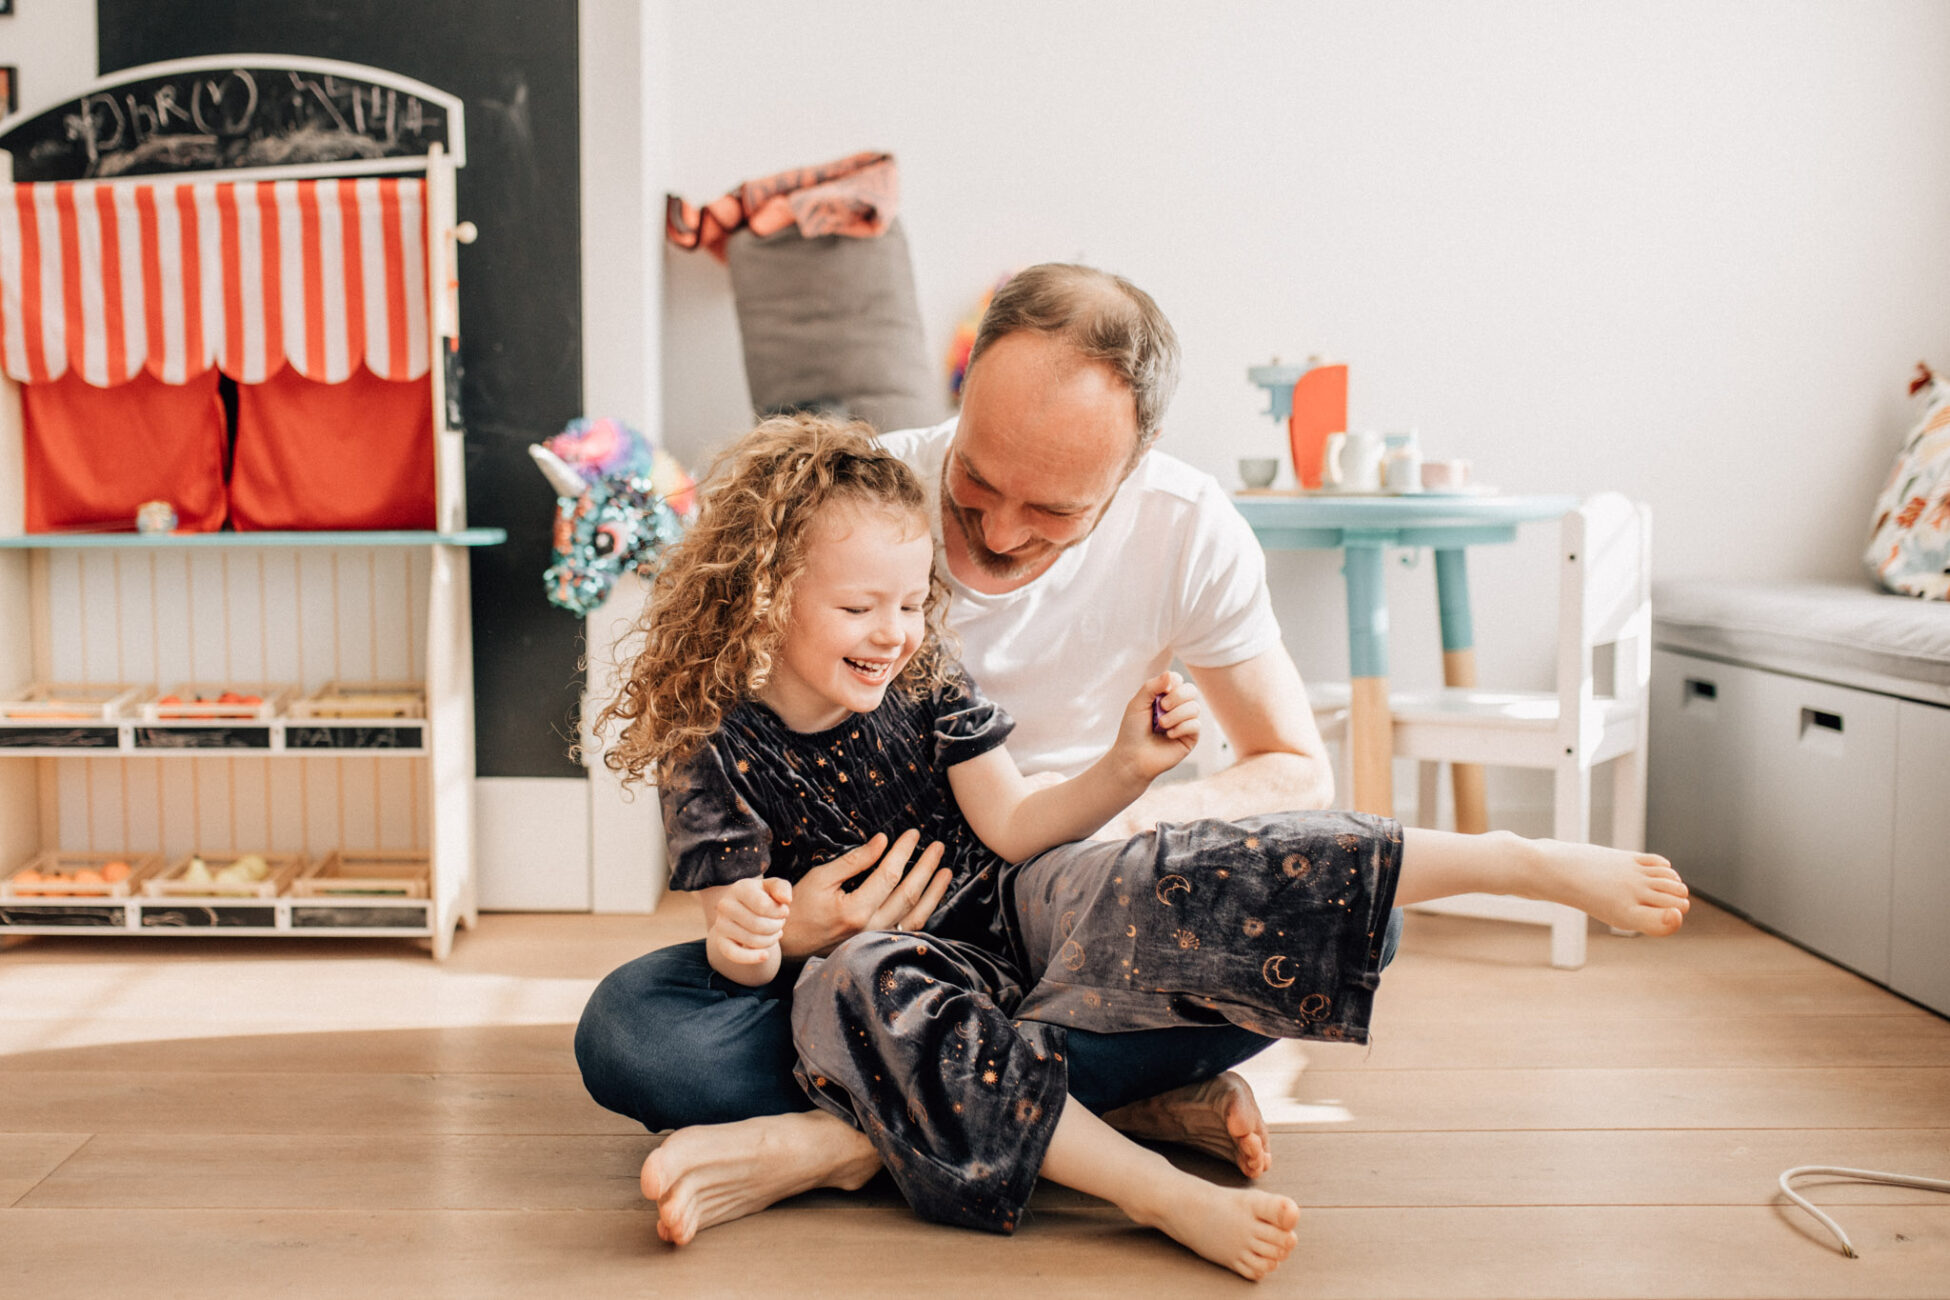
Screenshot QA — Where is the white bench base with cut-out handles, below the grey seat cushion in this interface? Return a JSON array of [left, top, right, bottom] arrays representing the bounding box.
[[1646, 649, 1950, 1012]]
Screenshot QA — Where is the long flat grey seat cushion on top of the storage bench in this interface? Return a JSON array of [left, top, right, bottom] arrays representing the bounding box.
[[1652, 581, 1950, 702]]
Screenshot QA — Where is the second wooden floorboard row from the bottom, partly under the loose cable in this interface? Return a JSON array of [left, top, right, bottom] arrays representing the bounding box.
[[18, 1128, 1950, 1210]]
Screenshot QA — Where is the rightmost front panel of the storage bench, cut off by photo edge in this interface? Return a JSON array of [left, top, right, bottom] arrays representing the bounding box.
[[1890, 700, 1950, 1015]]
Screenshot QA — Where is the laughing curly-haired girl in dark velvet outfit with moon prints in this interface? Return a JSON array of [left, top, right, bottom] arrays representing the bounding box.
[[599, 417, 1689, 1279]]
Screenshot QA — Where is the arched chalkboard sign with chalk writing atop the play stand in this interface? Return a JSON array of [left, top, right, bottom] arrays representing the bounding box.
[[0, 57, 466, 181]]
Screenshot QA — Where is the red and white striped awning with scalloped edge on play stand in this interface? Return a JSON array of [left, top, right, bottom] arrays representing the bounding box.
[[0, 177, 429, 388]]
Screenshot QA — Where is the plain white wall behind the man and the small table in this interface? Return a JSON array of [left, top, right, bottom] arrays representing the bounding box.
[[665, 0, 1950, 822]]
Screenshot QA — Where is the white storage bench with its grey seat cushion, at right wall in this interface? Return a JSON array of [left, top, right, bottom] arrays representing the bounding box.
[[1646, 583, 1950, 1015]]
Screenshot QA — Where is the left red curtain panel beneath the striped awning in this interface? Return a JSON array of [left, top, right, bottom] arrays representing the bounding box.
[[20, 370, 228, 532]]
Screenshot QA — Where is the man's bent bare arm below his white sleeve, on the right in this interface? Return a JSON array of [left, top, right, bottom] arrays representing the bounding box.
[[1096, 645, 1334, 840]]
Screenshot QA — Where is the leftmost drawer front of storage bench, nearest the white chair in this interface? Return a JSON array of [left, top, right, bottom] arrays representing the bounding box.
[[1646, 651, 1759, 912]]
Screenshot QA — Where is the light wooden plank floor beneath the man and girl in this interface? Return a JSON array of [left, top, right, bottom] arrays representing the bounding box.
[[0, 899, 1950, 1300]]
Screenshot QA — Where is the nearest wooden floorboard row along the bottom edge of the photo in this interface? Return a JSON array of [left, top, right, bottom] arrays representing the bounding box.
[[11, 1206, 1950, 1300]]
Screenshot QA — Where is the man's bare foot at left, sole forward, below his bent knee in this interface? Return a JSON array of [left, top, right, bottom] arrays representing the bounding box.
[[644, 1111, 879, 1245]]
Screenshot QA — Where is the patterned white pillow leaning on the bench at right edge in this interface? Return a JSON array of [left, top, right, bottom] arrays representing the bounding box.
[[1862, 366, 1950, 600]]
